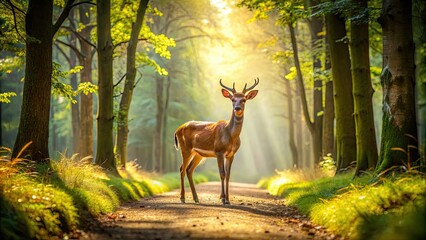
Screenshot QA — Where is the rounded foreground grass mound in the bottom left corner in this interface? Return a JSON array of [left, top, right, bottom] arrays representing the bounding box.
[[0, 152, 78, 239]]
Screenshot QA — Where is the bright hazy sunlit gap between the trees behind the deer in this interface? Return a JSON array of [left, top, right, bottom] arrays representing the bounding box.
[[195, 0, 292, 183]]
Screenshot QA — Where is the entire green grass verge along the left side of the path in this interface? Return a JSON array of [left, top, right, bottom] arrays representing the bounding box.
[[0, 157, 213, 239]]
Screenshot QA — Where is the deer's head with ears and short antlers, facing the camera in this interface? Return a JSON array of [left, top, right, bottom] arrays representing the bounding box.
[[219, 78, 259, 117]]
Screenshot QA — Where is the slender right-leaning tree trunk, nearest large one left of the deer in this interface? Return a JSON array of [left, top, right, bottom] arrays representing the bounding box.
[[116, 0, 148, 167]]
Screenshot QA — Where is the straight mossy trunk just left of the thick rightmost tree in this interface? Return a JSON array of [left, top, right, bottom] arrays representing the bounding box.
[[350, 0, 377, 176]]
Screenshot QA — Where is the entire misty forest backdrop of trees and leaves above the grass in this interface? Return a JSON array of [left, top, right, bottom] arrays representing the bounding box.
[[0, 0, 425, 181]]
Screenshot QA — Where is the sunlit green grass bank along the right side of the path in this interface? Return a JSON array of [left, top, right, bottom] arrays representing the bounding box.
[[259, 174, 426, 239]]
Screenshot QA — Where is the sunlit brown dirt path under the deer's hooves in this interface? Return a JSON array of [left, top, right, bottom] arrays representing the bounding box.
[[83, 182, 340, 240]]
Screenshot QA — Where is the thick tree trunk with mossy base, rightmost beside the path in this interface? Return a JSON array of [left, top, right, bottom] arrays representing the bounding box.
[[376, 0, 418, 173]]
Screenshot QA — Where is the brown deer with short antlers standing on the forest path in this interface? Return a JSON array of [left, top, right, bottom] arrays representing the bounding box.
[[174, 78, 259, 205]]
